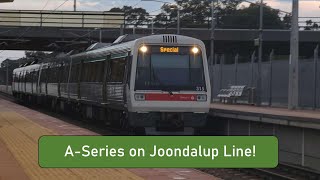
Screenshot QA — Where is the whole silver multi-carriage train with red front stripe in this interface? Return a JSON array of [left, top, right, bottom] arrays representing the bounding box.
[[12, 34, 211, 132]]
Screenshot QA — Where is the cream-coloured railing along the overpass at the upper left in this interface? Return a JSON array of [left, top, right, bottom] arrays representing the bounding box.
[[0, 10, 125, 28]]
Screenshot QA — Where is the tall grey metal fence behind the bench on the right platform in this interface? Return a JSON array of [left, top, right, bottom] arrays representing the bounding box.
[[210, 48, 320, 109]]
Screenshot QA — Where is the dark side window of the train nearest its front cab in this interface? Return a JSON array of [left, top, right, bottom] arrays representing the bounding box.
[[109, 57, 126, 82]]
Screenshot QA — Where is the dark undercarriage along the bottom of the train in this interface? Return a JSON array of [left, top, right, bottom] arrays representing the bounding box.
[[13, 92, 207, 135]]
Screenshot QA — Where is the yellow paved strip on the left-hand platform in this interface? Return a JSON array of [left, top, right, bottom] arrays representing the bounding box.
[[0, 112, 142, 180]]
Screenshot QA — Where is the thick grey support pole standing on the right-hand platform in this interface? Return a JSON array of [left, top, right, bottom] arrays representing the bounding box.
[[288, 0, 299, 109]]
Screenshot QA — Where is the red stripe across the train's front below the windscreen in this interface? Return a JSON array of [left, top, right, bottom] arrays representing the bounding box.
[[145, 94, 197, 101]]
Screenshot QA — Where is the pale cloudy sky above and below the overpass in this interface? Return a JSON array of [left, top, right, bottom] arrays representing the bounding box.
[[0, 0, 320, 62]]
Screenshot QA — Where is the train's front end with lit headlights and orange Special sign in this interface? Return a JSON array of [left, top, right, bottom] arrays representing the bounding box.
[[128, 35, 211, 134]]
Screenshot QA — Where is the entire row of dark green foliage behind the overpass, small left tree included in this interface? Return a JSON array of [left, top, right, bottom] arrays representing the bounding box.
[[110, 0, 290, 29]]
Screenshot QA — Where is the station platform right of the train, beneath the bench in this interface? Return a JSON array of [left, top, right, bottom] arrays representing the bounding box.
[[210, 103, 320, 130]]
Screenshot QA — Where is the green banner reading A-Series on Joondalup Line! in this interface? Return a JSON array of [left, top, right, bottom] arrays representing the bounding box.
[[39, 136, 278, 168]]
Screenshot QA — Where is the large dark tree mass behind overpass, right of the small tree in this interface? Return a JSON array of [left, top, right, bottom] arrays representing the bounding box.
[[155, 0, 291, 29]]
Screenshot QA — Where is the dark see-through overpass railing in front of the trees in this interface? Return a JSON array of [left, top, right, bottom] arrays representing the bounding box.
[[125, 14, 320, 30]]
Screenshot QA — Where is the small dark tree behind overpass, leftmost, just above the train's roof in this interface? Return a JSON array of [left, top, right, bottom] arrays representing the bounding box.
[[110, 6, 149, 27]]
